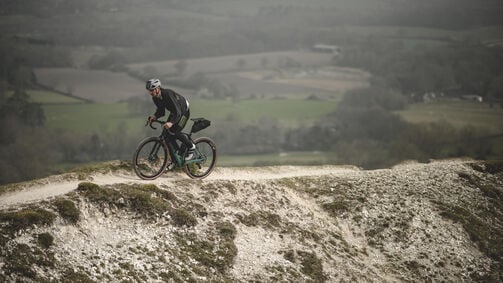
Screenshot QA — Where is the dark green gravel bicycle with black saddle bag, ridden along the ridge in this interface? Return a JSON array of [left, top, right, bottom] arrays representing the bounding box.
[[133, 118, 217, 180]]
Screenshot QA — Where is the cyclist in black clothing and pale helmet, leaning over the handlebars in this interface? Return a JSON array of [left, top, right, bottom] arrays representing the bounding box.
[[146, 79, 196, 160]]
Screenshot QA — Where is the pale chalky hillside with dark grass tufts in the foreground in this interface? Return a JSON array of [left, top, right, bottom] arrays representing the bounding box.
[[0, 160, 503, 282]]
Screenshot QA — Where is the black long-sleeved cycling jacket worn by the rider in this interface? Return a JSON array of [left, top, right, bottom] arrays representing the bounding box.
[[152, 88, 189, 128]]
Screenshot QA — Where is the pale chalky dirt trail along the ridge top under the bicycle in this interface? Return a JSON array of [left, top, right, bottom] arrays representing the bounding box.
[[0, 166, 359, 209]]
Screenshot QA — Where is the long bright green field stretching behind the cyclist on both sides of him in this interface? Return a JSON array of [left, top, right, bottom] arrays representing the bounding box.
[[43, 99, 337, 133]]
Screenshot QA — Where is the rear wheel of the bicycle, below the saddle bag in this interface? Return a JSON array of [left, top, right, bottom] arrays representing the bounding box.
[[184, 137, 217, 179]]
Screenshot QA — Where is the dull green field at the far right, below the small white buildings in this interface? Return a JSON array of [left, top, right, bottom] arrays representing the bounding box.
[[397, 100, 503, 134]]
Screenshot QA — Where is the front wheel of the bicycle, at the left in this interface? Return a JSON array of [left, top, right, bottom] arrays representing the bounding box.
[[133, 137, 171, 180]]
